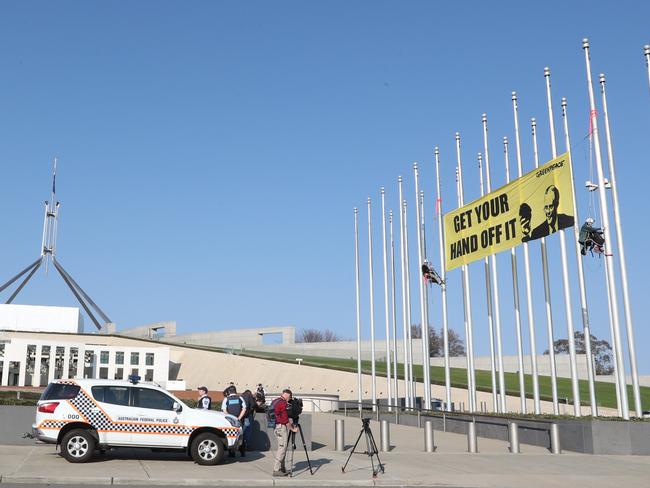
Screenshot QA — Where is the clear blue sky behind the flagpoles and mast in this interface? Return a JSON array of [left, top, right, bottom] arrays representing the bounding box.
[[0, 2, 650, 374]]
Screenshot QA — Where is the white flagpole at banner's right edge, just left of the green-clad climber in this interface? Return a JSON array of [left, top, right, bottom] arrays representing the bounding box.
[[562, 97, 598, 417]]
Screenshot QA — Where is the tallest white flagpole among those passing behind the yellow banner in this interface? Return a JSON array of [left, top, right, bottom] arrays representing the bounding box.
[[544, 67, 582, 417]]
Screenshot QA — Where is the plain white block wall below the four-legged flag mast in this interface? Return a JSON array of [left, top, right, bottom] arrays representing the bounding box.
[[0, 304, 84, 333]]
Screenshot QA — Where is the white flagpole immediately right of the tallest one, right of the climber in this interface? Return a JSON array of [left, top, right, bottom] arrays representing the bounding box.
[[600, 74, 643, 417]]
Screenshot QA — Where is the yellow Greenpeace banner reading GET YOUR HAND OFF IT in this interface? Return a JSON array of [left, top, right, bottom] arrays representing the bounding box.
[[445, 153, 575, 270]]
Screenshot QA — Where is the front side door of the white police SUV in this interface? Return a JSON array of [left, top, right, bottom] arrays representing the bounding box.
[[131, 386, 185, 447]]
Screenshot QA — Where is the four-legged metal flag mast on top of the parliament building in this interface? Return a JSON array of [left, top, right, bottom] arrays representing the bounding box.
[[0, 158, 112, 330]]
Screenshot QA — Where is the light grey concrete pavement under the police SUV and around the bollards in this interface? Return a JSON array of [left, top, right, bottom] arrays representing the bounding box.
[[0, 414, 650, 488]]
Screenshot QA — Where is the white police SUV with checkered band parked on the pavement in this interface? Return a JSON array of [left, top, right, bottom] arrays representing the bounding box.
[[32, 377, 242, 465]]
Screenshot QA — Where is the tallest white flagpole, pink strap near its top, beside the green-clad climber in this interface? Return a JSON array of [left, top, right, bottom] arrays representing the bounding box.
[[582, 39, 630, 420]]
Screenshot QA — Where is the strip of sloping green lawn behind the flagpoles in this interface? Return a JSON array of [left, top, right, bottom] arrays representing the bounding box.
[[210, 351, 650, 410]]
